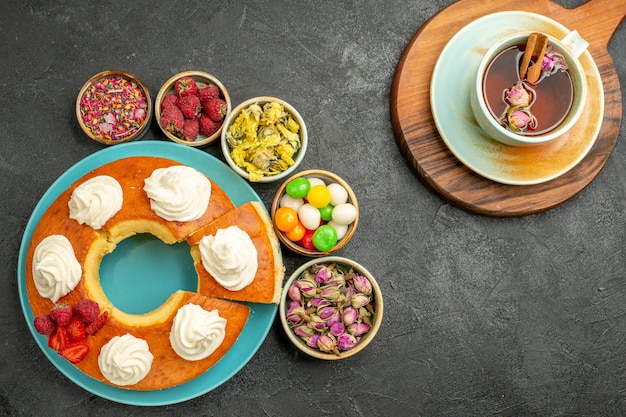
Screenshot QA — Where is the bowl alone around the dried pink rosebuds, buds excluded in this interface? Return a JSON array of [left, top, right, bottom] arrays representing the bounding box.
[[278, 256, 384, 360]]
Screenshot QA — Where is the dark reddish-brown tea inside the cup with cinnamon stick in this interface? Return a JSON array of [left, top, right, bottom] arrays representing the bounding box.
[[483, 44, 574, 136]]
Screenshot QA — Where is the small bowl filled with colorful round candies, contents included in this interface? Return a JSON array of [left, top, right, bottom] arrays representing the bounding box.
[[270, 169, 359, 257]]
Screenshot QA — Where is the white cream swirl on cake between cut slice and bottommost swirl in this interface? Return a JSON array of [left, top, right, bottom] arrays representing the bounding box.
[[170, 304, 226, 361]]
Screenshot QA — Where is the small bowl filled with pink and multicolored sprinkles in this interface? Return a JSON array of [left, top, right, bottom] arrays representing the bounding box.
[[76, 71, 152, 145]]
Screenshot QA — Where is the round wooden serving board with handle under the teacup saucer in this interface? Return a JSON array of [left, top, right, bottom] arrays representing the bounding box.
[[391, 0, 626, 217]]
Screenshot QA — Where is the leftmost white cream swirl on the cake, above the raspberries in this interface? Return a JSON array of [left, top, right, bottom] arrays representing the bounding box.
[[32, 235, 83, 303]]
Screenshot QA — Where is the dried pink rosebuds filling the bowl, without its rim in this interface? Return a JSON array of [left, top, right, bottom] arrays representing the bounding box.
[[285, 263, 376, 354]]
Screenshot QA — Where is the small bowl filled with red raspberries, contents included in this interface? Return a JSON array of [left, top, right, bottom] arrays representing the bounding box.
[[154, 71, 231, 147]]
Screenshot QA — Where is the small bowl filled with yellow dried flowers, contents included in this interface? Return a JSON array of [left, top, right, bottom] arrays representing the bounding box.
[[221, 96, 308, 182]]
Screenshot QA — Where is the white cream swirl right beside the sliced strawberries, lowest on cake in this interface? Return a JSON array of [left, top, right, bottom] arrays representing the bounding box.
[[98, 333, 154, 386]]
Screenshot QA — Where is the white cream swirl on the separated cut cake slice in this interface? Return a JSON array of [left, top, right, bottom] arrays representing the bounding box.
[[199, 226, 258, 291]]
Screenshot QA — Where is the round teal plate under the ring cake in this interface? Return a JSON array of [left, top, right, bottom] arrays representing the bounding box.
[[17, 141, 278, 406]]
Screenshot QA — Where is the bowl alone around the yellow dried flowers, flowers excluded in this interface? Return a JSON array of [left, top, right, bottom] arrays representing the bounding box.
[[221, 96, 308, 183]]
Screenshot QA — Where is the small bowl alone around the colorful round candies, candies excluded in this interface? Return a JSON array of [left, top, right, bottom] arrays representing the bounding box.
[[270, 169, 360, 257]]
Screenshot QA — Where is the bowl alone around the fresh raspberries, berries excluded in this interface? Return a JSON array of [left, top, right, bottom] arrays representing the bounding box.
[[154, 71, 231, 147]]
